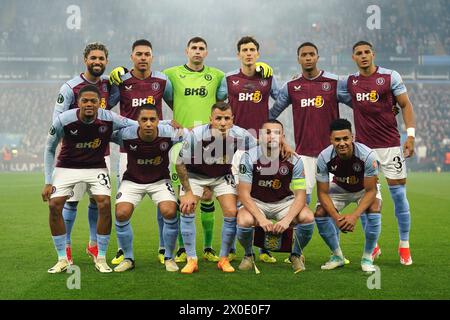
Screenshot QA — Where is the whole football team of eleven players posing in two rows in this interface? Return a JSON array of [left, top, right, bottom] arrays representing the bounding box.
[[42, 35, 416, 277]]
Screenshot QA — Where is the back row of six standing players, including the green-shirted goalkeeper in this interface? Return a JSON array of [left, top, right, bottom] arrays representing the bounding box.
[[44, 37, 415, 272]]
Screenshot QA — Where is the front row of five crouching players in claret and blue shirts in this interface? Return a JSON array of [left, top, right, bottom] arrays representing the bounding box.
[[42, 85, 381, 274]]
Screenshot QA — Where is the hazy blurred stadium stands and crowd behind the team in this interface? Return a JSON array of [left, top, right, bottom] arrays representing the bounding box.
[[0, 0, 450, 171]]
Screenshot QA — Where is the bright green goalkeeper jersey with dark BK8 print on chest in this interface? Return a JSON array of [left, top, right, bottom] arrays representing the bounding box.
[[163, 65, 227, 128]]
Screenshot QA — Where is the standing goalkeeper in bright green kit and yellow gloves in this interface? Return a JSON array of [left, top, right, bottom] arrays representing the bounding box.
[[110, 37, 272, 262]]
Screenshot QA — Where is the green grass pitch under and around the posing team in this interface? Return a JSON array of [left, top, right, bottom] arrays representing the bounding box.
[[0, 173, 450, 300]]
